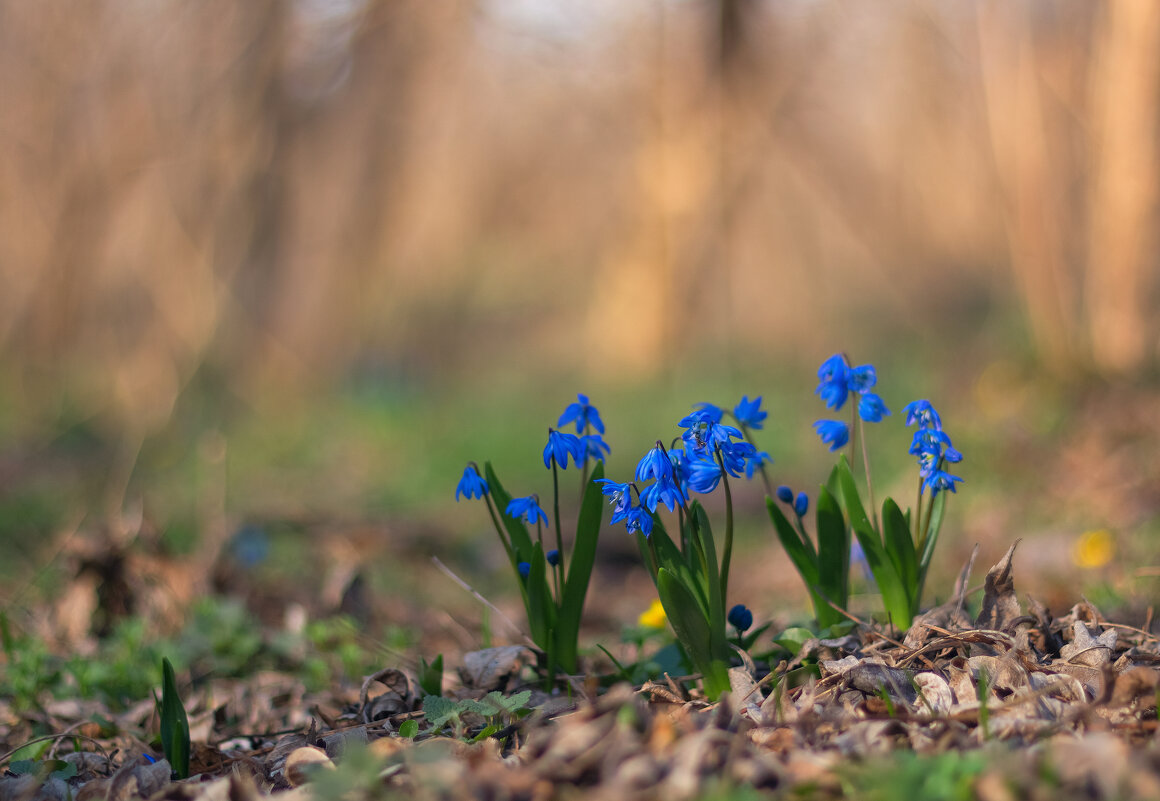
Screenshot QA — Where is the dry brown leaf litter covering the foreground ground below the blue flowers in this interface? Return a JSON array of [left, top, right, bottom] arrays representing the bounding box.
[[0, 543, 1160, 801]]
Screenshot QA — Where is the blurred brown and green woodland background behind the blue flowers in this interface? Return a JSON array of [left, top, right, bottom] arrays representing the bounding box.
[[0, 0, 1160, 653]]
